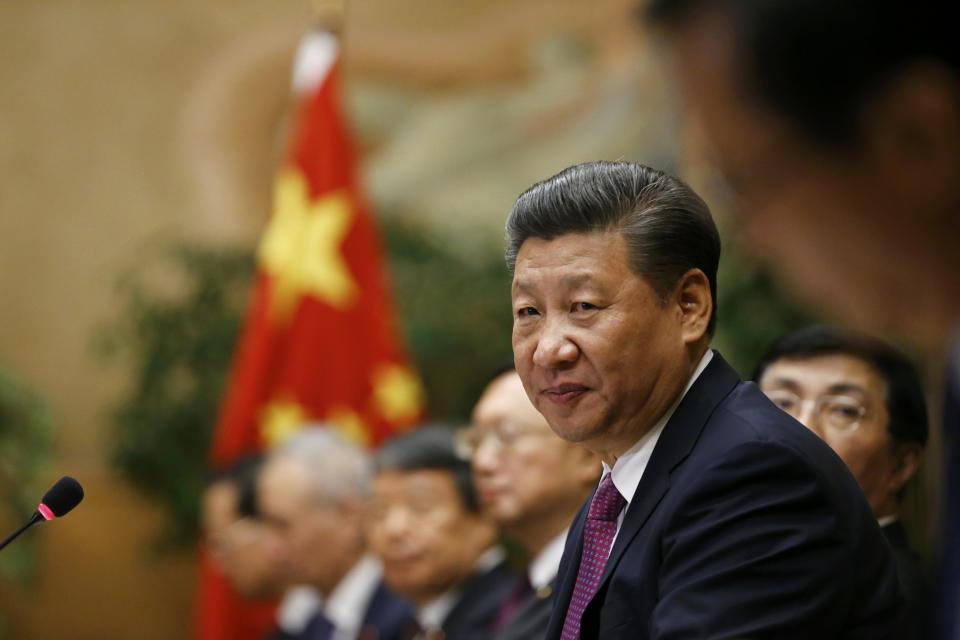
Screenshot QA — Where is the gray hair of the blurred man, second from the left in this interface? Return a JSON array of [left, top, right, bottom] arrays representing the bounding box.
[[270, 423, 373, 502]]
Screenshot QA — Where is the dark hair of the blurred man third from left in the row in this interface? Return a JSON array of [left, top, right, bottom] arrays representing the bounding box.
[[373, 424, 480, 512]]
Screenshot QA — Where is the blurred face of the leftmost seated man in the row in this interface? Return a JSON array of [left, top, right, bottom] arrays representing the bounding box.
[[203, 482, 283, 598]]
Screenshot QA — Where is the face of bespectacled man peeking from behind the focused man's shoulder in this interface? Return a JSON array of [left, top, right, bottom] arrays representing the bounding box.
[[759, 355, 903, 517]]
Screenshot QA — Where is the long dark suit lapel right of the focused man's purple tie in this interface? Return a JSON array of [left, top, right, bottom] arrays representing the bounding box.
[[596, 351, 740, 598]]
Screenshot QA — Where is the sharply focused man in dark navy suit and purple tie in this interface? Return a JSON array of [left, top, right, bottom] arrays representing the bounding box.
[[507, 162, 901, 640]]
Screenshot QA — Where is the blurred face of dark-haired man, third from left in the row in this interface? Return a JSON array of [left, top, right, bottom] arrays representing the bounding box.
[[368, 469, 496, 604]]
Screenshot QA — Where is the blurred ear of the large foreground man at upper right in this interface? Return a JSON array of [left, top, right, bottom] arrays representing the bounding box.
[[862, 63, 960, 222]]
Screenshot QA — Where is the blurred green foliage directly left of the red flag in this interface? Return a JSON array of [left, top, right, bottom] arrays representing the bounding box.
[[99, 246, 253, 544]]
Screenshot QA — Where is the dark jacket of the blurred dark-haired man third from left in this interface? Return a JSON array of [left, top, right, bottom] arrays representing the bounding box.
[[441, 562, 517, 640]]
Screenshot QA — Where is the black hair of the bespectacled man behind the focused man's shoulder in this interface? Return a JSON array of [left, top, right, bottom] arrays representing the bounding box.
[[753, 325, 929, 445]]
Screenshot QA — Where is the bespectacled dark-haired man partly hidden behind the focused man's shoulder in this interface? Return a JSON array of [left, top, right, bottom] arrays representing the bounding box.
[[754, 326, 927, 637]]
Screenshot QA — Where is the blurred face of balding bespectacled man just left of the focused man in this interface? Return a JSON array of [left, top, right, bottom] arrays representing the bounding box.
[[471, 371, 600, 530]]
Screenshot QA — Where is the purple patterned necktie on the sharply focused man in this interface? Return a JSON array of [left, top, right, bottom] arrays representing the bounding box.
[[560, 473, 627, 640]]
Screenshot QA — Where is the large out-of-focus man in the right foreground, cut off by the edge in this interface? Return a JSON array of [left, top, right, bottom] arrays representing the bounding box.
[[649, 0, 960, 640]]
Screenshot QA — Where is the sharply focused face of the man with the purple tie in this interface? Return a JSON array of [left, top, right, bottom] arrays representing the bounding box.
[[512, 232, 689, 462]]
